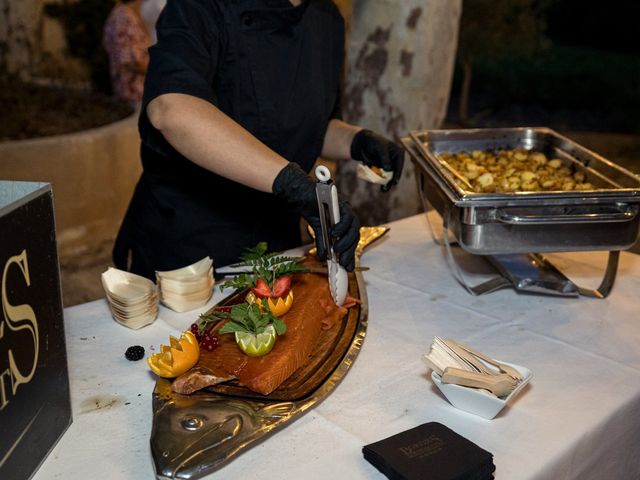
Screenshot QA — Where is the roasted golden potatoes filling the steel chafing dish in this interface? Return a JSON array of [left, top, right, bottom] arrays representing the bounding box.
[[439, 149, 594, 193]]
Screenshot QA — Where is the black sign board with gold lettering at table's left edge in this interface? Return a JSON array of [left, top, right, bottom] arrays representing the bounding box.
[[0, 187, 71, 480]]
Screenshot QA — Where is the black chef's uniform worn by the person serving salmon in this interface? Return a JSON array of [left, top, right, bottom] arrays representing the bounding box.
[[114, 0, 344, 278]]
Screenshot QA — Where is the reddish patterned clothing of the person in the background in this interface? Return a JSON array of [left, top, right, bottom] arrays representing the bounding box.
[[102, 4, 151, 103]]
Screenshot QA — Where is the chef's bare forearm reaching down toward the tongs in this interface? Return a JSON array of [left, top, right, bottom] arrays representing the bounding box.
[[147, 93, 288, 192]]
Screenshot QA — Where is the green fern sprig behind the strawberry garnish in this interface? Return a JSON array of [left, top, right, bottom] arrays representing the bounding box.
[[220, 242, 309, 290]]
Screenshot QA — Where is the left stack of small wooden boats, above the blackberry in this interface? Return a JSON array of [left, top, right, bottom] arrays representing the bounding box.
[[102, 267, 158, 330]]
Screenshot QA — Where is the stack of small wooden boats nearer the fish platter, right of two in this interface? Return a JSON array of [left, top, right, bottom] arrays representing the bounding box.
[[156, 257, 214, 312]]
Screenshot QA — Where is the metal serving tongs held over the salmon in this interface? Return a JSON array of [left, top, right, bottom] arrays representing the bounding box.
[[316, 165, 348, 306]]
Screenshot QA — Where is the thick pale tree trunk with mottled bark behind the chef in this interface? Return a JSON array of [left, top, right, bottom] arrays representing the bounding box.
[[337, 0, 462, 225]]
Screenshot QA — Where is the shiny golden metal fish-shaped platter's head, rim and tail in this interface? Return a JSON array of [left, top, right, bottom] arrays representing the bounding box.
[[150, 227, 389, 479]]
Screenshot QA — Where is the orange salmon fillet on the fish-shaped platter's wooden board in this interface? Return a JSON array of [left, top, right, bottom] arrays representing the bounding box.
[[172, 273, 347, 395]]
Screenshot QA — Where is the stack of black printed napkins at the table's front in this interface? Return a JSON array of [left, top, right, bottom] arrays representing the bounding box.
[[362, 422, 496, 480]]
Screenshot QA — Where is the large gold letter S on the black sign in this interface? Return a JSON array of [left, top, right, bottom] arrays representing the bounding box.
[[0, 250, 39, 395]]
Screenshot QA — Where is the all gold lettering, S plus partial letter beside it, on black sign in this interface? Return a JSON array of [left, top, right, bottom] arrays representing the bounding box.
[[0, 250, 40, 410]]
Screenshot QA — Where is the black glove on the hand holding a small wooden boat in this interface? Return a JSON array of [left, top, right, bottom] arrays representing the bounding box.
[[351, 130, 404, 192]]
